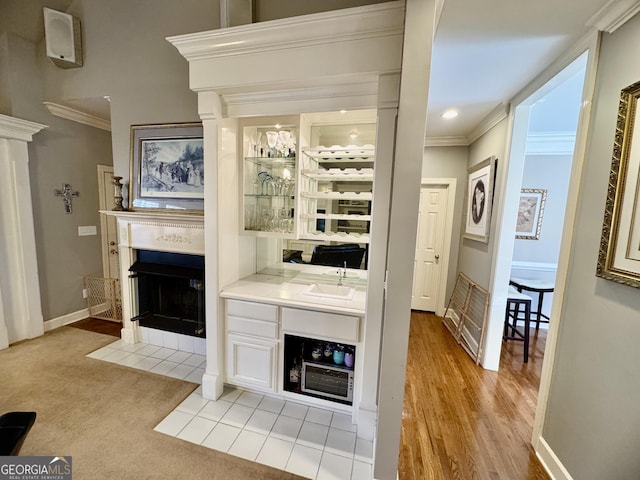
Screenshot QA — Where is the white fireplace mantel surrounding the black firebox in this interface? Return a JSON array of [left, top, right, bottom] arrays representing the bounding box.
[[100, 210, 204, 343]]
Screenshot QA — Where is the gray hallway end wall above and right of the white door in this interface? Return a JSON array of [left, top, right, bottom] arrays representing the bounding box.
[[422, 147, 469, 301]]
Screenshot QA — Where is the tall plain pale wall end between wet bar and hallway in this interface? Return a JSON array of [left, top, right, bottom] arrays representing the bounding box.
[[373, 0, 435, 480]]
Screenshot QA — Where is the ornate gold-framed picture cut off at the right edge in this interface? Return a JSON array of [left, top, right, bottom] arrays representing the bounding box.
[[596, 82, 640, 288]]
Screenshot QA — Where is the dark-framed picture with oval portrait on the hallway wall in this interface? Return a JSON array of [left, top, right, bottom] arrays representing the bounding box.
[[463, 156, 496, 243]]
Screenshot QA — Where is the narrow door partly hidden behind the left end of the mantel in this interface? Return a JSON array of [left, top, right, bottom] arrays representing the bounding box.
[[98, 165, 120, 279]]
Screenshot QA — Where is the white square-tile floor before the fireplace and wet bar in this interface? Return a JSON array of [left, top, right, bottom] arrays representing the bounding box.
[[88, 340, 373, 480]]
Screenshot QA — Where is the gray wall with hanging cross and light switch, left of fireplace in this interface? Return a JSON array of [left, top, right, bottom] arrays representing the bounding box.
[[0, 34, 112, 320]]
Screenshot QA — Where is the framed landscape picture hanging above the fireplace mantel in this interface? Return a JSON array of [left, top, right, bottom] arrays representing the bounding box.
[[129, 123, 205, 213]]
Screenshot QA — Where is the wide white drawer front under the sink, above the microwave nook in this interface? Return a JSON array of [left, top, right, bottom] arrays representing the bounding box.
[[282, 307, 360, 342]]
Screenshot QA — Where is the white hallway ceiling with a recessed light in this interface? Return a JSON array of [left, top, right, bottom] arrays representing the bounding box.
[[427, 0, 609, 143]]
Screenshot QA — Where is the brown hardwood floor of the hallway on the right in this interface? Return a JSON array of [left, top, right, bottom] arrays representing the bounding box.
[[398, 311, 549, 480]]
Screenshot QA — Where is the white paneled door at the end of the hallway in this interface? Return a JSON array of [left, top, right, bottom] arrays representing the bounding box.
[[411, 185, 448, 312]]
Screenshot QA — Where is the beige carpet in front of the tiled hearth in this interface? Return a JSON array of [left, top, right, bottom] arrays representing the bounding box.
[[0, 327, 301, 480]]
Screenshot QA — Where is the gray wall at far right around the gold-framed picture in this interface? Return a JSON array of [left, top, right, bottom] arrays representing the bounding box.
[[543, 10, 640, 480]]
